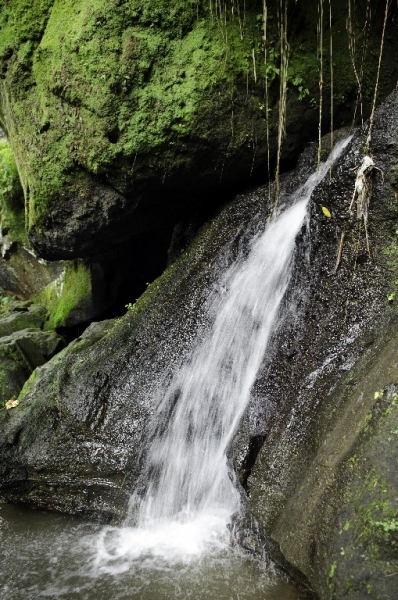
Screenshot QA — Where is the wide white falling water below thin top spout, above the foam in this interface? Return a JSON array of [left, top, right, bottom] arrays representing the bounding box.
[[138, 199, 307, 527]]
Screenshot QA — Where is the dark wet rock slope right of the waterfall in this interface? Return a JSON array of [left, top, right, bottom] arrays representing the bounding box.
[[246, 93, 398, 598]]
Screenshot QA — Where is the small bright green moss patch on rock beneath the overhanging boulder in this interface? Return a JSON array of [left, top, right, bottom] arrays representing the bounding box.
[[35, 260, 92, 329]]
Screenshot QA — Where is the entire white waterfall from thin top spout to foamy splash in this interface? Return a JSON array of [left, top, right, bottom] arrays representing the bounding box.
[[95, 138, 350, 568]]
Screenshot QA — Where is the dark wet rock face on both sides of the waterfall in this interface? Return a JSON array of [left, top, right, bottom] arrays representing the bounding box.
[[0, 93, 398, 598]]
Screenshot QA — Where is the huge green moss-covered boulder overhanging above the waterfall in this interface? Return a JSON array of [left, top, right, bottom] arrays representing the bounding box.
[[0, 0, 396, 258]]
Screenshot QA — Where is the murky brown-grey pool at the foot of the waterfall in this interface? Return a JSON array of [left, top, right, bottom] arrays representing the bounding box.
[[0, 505, 310, 600]]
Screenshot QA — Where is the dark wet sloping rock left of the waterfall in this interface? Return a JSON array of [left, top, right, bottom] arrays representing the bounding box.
[[0, 213, 239, 520]]
